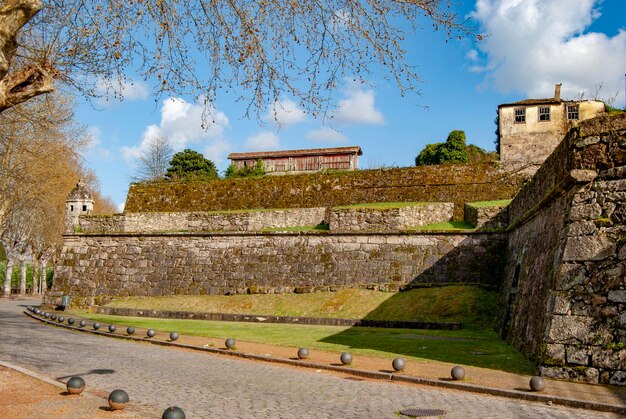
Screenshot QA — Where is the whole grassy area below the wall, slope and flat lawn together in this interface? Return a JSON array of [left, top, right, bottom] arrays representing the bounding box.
[[75, 285, 532, 373]]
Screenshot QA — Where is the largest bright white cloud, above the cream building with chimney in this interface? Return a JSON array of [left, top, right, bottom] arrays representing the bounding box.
[[468, 0, 626, 105]]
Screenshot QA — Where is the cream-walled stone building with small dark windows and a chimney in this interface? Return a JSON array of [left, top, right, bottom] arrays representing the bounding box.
[[498, 83, 604, 166]]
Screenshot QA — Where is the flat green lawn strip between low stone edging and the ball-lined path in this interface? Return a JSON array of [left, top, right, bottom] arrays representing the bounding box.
[[72, 311, 532, 374]]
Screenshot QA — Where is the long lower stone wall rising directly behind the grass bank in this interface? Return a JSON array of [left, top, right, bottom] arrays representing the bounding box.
[[57, 232, 506, 298]]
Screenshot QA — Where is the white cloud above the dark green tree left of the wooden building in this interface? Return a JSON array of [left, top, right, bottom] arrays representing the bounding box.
[[121, 98, 229, 161]]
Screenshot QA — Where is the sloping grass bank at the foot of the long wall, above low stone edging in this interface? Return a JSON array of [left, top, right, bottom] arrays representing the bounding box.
[[107, 286, 497, 327]]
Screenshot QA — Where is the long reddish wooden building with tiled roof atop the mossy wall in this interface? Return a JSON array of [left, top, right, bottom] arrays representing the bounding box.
[[228, 146, 363, 174]]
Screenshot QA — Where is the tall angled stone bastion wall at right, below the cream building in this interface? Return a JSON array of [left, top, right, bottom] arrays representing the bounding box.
[[499, 114, 626, 384]]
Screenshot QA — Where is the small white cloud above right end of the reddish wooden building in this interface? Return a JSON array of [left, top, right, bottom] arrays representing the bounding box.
[[333, 84, 385, 125]]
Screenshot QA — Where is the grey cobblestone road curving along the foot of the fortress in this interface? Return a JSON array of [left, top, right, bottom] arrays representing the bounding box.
[[0, 300, 618, 419]]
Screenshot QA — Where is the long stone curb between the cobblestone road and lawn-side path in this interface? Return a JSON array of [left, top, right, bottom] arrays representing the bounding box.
[[24, 311, 626, 415]]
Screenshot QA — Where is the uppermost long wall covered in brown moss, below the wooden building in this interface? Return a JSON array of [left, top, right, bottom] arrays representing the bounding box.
[[125, 164, 522, 220]]
